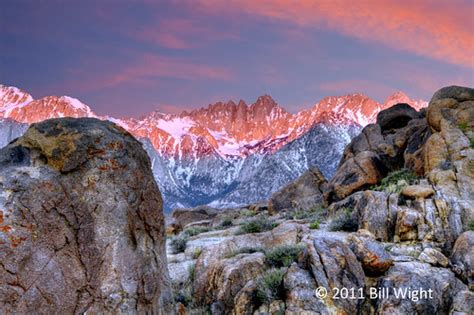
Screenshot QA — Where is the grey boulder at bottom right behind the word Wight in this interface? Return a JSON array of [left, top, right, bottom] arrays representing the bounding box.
[[375, 262, 474, 314]]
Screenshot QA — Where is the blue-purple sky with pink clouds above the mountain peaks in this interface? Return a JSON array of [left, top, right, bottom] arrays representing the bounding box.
[[0, 0, 474, 117]]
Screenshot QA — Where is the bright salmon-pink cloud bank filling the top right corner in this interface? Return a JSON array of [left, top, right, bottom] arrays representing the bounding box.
[[201, 0, 474, 67]]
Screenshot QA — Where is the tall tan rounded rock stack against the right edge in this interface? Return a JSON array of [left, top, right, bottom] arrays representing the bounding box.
[[424, 86, 474, 245]]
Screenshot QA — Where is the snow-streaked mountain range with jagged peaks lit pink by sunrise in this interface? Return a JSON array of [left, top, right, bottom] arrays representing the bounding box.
[[0, 85, 427, 210]]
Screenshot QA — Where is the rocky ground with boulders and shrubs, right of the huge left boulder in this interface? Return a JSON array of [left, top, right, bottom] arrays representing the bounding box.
[[167, 87, 474, 314]]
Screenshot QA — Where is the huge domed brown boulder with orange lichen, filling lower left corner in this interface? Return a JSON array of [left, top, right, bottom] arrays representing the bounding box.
[[0, 118, 173, 314]]
